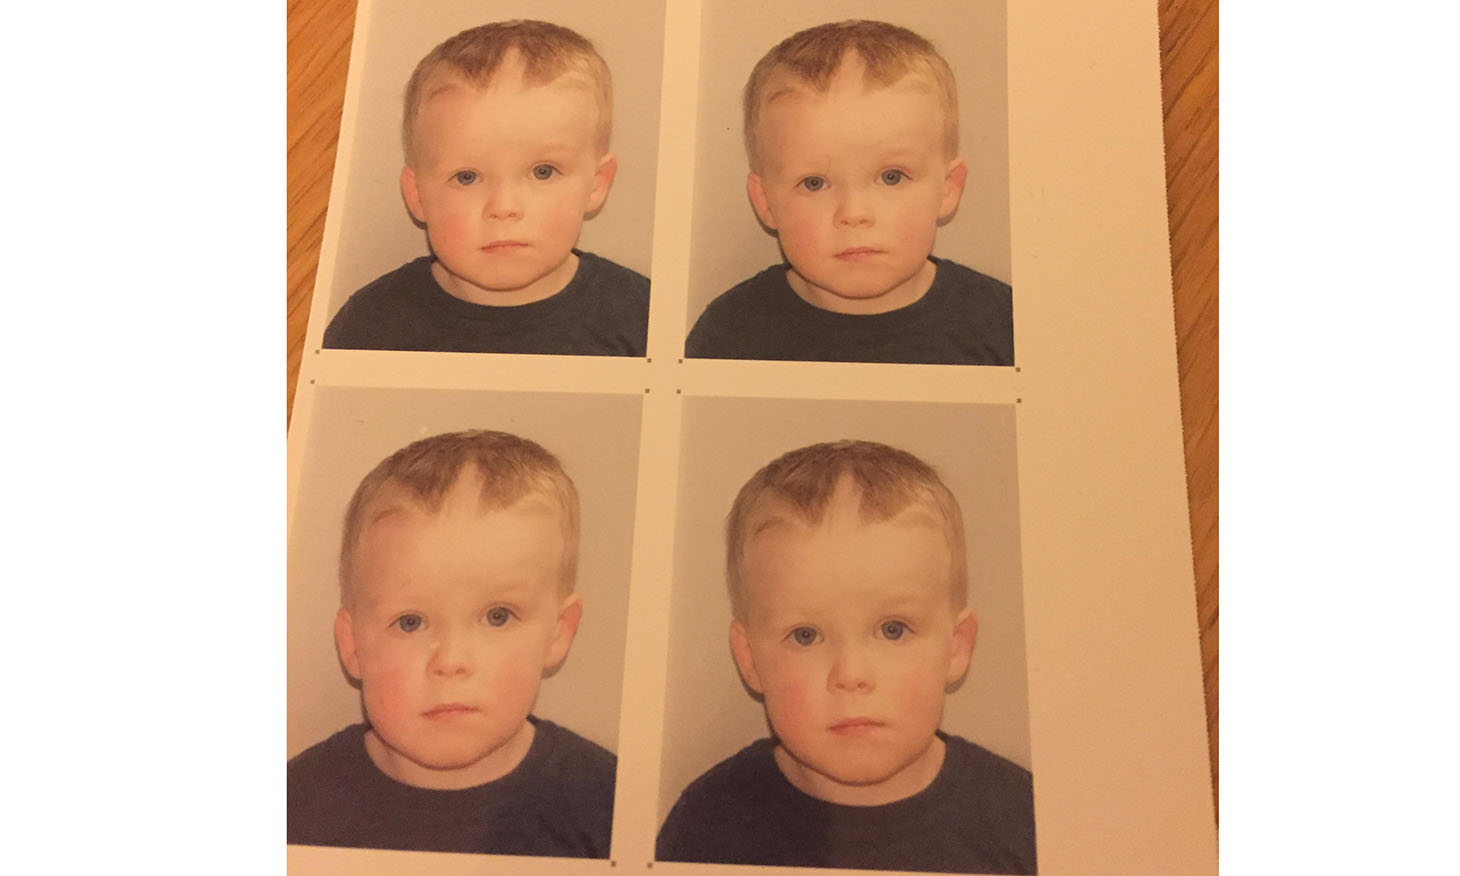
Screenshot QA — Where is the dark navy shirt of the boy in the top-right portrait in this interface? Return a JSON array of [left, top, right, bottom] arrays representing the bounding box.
[[685, 258, 1013, 365]]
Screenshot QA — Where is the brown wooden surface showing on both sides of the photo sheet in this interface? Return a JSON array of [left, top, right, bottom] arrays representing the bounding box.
[[286, 0, 1218, 799]]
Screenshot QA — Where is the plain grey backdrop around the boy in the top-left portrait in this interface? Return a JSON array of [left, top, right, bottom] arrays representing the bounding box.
[[326, 0, 664, 318]]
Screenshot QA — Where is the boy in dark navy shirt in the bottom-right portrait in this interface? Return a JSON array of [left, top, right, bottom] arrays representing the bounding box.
[[657, 441, 1035, 873]]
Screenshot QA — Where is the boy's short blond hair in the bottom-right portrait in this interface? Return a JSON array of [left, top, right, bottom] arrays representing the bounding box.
[[726, 441, 968, 621]]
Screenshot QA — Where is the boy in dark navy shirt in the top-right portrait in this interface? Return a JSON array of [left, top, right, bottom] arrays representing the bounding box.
[[685, 20, 1013, 365]]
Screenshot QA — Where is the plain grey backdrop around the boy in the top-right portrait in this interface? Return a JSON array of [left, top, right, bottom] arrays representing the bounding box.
[[685, 0, 1018, 333]]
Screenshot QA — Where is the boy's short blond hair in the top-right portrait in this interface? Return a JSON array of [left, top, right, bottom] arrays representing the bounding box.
[[745, 20, 958, 171]]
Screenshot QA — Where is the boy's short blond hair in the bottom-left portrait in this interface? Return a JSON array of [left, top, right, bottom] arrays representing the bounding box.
[[340, 429, 580, 607]]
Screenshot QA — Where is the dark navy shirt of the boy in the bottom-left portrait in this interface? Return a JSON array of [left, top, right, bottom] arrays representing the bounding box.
[[288, 717, 618, 857]]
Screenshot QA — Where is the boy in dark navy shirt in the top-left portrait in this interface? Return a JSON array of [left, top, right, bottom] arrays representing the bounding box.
[[324, 20, 648, 356]]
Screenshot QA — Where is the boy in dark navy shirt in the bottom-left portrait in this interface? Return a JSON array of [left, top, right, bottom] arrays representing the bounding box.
[[288, 431, 616, 857]]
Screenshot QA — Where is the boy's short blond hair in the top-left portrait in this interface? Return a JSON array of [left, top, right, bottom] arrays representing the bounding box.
[[400, 19, 613, 165]]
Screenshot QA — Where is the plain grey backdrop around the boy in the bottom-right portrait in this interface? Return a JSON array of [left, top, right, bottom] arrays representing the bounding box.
[[658, 397, 1029, 823]]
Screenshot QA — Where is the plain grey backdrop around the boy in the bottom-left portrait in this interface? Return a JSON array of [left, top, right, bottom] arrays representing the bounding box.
[[288, 387, 642, 758]]
